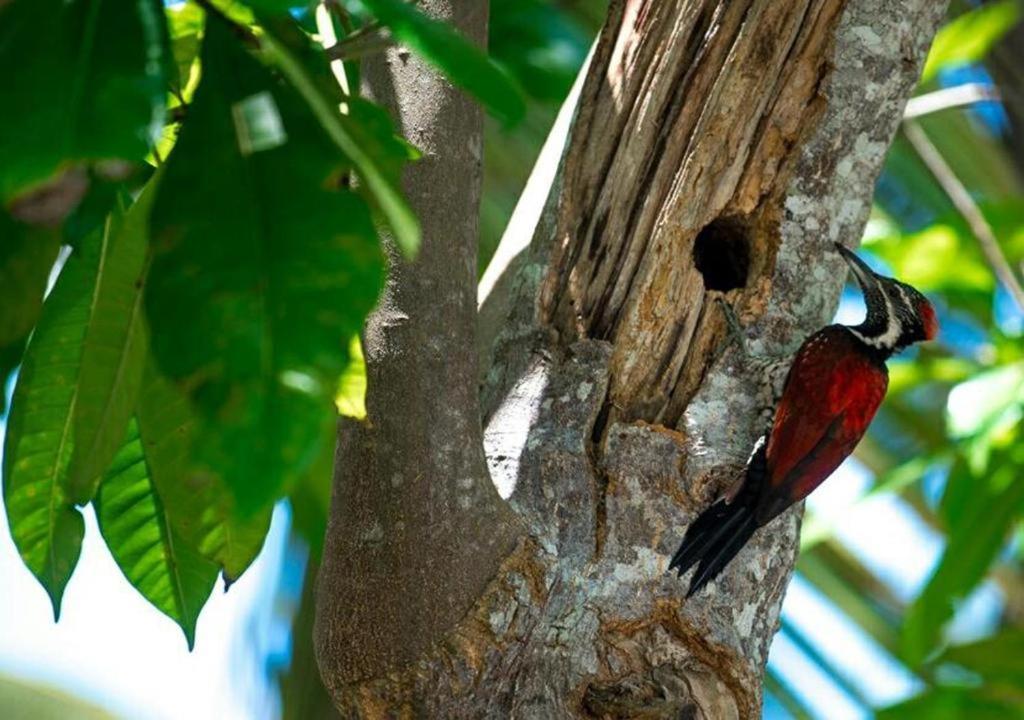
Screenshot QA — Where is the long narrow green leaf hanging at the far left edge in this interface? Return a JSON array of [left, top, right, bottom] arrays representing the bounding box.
[[3, 236, 100, 618]]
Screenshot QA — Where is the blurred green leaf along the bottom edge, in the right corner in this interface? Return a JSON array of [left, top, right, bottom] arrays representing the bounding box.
[[874, 687, 1024, 720]]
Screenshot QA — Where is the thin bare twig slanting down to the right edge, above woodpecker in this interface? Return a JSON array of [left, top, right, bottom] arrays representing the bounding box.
[[903, 121, 1024, 312]]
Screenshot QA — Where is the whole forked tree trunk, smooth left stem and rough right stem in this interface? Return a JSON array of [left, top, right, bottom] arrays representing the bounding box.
[[315, 0, 945, 720]]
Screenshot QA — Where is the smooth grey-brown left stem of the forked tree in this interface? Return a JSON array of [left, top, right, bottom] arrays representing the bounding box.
[[316, 0, 517, 683]]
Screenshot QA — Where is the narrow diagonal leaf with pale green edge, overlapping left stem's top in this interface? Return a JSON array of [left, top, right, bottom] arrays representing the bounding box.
[[260, 17, 420, 257]]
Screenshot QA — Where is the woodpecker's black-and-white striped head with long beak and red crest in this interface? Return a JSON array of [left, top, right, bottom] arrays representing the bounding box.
[[836, 243, 939, 356]]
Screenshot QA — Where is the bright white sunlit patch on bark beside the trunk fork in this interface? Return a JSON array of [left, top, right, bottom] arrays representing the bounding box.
[[483, 359, 548, 500]]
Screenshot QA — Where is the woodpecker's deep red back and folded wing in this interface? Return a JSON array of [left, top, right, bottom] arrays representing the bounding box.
[[765, 325, 889, 512]]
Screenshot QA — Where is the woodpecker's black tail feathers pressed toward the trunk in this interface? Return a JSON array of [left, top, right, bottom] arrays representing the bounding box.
[[669, 443, 764, 597]]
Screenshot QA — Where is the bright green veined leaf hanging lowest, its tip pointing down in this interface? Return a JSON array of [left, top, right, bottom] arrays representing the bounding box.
[[96, 421, 218, 649]]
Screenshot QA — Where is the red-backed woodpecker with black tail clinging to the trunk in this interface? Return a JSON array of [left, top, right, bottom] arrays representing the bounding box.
[[669, 243, 938, 597]]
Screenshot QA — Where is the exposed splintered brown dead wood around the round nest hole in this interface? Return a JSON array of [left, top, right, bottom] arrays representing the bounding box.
[[542, 0, 845, 427]]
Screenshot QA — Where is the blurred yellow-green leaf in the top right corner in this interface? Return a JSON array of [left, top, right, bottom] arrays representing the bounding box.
[[921, 0, 1021, 83]]
